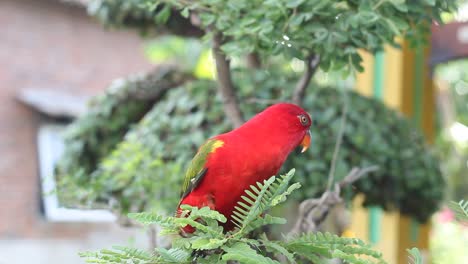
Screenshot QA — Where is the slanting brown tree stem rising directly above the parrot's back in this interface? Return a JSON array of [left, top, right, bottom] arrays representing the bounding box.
[[213, 33, 244, 127]]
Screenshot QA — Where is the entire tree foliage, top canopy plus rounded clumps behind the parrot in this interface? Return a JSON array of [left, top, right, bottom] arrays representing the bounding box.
[[57, 0, 455, 223]]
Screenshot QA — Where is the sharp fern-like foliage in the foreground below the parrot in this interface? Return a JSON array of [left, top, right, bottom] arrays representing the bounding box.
[[81, 170, 385, 264]]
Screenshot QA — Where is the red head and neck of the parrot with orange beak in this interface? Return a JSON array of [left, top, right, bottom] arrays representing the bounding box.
[[241, 103, 312, 153]]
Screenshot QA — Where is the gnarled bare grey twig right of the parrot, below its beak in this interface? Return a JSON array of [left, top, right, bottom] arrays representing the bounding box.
[[289, 166, 378, 235]]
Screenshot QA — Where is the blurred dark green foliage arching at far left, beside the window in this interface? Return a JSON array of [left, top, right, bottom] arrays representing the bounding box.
[[56, 66, 191, 207]]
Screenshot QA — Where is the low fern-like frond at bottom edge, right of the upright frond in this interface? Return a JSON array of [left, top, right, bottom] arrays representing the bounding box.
[[284, 232, 385, 263]]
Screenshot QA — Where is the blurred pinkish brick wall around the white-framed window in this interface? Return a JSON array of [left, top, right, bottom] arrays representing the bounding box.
[[0, 0, 150, 239]]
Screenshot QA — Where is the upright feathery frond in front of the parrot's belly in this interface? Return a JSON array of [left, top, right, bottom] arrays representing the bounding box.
[[232, 169, 300, 236]]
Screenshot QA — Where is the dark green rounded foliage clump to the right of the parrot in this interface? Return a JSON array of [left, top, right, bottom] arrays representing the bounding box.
[[298, 86, 445, 221]]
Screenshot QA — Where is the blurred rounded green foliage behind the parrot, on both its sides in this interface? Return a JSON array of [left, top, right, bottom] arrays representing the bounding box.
[[57, 67, 444, 221]]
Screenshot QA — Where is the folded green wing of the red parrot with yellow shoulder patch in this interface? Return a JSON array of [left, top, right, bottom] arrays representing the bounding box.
[[181, 139, 224, 199]]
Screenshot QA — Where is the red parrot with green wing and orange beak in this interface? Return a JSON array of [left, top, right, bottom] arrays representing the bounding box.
[[176, 103, 312, 233]]
